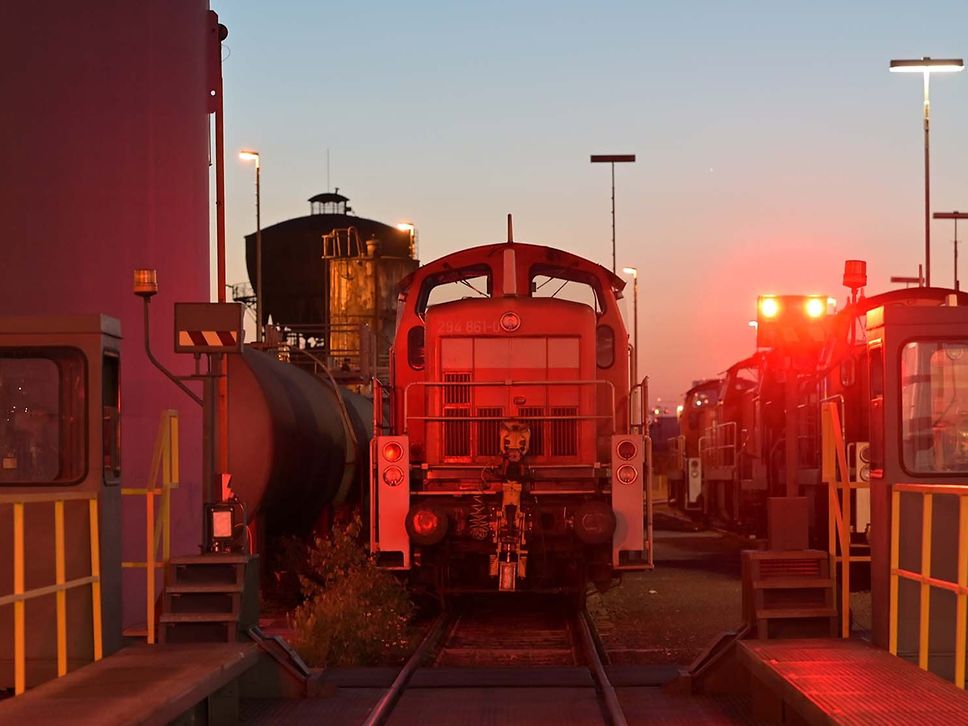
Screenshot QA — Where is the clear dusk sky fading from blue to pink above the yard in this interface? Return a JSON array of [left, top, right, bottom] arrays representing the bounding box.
[[213, 0, 968, 405]]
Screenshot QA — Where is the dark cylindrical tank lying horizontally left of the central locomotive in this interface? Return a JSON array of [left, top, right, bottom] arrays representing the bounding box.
[[226, 347, 373, 538]]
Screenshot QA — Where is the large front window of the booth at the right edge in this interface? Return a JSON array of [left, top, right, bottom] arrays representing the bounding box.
[[901, 341, 968, 474]]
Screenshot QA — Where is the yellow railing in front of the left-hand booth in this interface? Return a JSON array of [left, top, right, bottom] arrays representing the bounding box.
[[0, 492, 102, 696]]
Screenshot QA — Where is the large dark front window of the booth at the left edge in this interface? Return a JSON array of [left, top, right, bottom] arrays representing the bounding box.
[[0, 348, 87, 486]]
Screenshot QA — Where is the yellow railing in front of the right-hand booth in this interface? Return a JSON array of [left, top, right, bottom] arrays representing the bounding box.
[[890, 484, 968, 688]]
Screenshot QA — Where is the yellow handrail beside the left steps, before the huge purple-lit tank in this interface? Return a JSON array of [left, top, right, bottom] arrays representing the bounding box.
[[121, 409, 179, 645]]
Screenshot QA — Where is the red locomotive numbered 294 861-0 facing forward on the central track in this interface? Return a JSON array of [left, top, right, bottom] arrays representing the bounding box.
[[370, 234, 651, 595]]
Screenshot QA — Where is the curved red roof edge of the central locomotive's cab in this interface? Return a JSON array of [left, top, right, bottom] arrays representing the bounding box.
[[399, 242, 625, 297]]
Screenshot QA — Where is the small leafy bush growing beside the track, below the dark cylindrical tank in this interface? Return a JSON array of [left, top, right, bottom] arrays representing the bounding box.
[[292, 516, 413, 667]]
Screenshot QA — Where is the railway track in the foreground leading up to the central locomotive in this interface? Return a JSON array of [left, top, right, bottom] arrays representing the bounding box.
[[364, 597, 627, 726]]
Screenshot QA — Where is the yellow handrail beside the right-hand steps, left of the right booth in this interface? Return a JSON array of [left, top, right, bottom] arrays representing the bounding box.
[[820, 400, 871, 638]]
